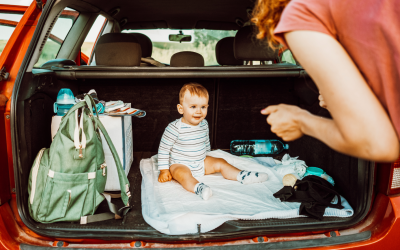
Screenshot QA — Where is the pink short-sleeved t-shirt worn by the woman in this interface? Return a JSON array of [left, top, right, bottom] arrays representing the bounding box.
[[275, 0, 400, 139]]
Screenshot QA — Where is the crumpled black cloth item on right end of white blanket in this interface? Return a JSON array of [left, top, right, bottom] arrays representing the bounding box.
[[274, 175, 343, 220]]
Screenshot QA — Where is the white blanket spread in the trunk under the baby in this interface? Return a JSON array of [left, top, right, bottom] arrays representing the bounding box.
[[140, 150, 354, 235]]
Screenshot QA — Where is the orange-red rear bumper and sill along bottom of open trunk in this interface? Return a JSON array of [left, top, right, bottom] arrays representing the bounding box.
[[0, 194, 400, 249]]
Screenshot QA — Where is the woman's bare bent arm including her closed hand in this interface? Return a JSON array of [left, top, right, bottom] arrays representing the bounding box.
[[262, 31, 399, 161]]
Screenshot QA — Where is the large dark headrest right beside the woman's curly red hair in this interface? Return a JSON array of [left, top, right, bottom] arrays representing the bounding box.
[[234, 25, 278, 61]]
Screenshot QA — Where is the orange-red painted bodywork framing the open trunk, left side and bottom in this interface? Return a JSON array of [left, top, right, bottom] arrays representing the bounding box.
[[0, 1, 400, 249]]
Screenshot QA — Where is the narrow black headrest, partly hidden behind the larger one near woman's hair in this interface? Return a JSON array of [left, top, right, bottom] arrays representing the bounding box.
[[215, 37, 243, 65]]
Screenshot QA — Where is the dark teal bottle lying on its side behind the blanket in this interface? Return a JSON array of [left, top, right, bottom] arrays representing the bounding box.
[[231, 140, 289, 155]]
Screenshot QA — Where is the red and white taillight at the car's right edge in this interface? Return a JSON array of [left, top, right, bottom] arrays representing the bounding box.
[[378, 158, 400, 195]]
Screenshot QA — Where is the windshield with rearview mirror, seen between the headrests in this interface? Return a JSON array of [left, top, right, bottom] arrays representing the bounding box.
[[122, 29, 237, 66]]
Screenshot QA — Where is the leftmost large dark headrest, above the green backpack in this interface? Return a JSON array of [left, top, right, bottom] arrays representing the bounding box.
[[95, 33, 142, 67]]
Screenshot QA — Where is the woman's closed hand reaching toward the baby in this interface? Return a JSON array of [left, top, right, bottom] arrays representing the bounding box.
[[261, 104, 309, 141]]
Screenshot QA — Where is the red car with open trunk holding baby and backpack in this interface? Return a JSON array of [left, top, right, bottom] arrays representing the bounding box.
[[0, 0, 400, 250]]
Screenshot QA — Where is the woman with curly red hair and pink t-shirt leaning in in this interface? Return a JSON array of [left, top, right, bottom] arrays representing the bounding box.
[[252, 0, 400, 162]]
